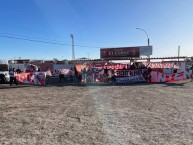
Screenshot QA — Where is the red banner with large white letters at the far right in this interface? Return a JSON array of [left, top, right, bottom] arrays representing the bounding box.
[[151, 70, 192, 82]]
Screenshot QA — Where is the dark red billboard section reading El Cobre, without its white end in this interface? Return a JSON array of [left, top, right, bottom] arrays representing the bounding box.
[[100, 47, 140, 59]]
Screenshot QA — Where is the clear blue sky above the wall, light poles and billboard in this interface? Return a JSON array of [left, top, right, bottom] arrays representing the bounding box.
[[0, 0, 193, 60]]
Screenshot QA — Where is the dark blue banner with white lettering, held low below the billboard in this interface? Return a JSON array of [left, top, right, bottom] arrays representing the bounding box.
[[116, 75, 146, 84]]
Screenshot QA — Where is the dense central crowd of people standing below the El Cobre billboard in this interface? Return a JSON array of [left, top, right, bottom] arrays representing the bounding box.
[[55, 64, 152, 83]]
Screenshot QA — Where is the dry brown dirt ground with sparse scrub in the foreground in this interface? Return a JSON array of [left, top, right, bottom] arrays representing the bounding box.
[[0, 80, 193, 145]]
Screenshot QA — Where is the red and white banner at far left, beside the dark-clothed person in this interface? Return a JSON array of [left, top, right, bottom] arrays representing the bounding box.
[[16, 72, 46, 85]]
